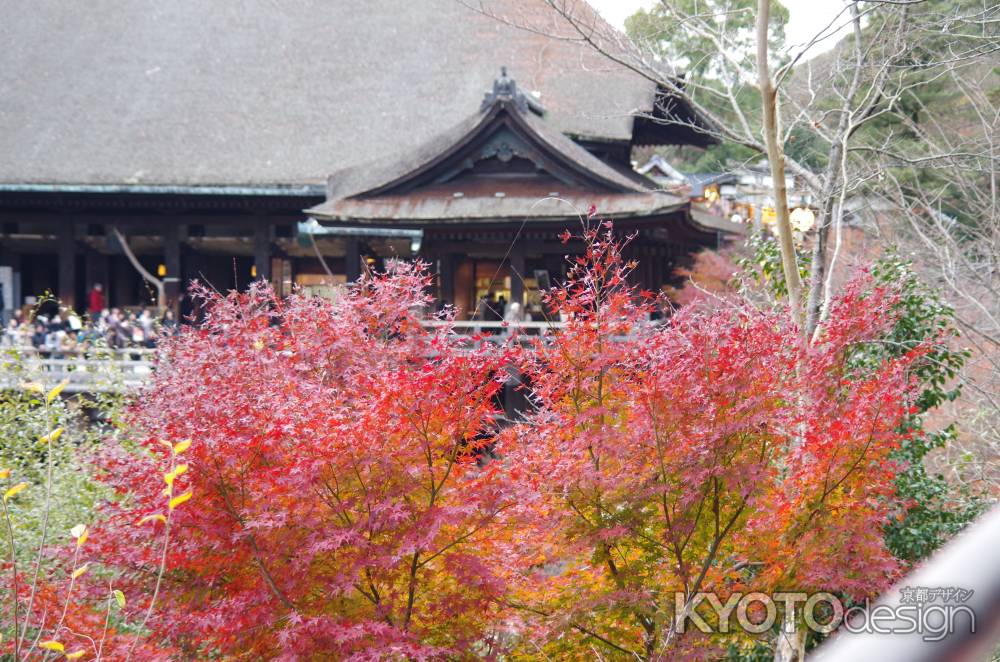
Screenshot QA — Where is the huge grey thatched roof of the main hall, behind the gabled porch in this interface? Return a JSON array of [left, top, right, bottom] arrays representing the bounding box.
[[0, 0, 680, 188]]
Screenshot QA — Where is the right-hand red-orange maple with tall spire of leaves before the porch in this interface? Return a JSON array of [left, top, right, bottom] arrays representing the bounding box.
[[501, 227, 919, 659]]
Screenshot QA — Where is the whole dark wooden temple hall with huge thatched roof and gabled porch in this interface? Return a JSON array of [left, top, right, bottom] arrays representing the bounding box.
[[0, 0, 734, 322]]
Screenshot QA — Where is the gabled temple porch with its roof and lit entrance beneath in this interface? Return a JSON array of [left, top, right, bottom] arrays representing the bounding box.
[[307, 70, 728, 314]]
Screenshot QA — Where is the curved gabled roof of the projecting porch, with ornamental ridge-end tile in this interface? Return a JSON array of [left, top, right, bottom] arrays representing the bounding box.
[[307, 71, 736, 236]]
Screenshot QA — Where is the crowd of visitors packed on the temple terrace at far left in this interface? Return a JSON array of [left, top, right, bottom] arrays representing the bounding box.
[[0, 285, 177, 356]]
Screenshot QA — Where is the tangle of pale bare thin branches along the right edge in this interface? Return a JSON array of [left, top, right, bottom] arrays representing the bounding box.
[[856, 58, 1000, 493]]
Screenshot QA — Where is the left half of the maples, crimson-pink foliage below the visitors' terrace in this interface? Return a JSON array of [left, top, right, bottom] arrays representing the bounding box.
[[89, 263, 509, 659]]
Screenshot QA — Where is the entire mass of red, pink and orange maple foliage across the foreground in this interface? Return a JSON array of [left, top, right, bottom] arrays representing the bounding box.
[[17, 225, 919, 659]]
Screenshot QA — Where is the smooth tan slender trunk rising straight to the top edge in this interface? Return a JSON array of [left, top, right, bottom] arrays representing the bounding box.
[[757, 0, 805, 333]]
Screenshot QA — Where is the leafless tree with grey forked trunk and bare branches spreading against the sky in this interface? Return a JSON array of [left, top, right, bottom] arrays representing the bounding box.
[[461, 0, 996, 334]]
